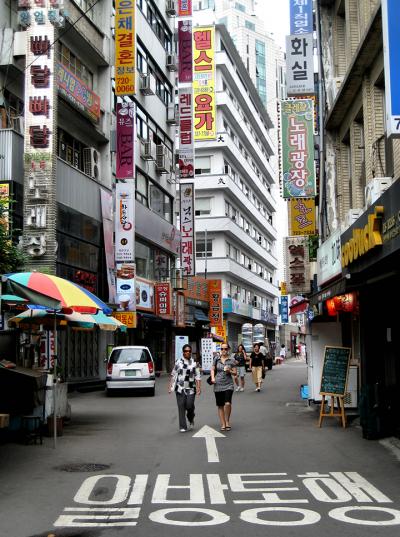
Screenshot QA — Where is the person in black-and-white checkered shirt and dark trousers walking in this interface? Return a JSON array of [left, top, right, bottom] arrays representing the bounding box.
[[168, 345, 201, 433]]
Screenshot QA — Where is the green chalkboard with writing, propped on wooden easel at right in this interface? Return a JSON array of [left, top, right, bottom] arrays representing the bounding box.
[[320, 347, 351, 395]]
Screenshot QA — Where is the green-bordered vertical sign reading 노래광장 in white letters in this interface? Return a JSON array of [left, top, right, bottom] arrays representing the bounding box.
[[281, 99, 316, 198]]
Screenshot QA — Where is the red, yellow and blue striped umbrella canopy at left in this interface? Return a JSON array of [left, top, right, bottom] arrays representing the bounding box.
[[3, 272, 112, 314]]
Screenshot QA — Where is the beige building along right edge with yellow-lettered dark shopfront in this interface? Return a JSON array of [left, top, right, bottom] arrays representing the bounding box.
[[310, 0, 400, 438]]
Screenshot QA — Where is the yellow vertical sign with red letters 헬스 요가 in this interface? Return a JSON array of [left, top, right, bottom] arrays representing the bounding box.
[[193, 26, 216, 140]]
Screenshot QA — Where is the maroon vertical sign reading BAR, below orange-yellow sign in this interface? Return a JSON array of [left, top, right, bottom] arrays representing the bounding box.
[[115, 102, 135, 179]]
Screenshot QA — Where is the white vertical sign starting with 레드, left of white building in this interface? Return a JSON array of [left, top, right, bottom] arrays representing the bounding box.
[[178, 86, 194, 179]]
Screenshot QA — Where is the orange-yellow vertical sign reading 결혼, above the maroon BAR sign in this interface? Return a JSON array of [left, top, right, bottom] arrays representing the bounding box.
[[115, 0, 136, 95]]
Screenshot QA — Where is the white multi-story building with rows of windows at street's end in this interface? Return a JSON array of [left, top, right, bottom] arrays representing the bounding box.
[[189, 14, 278, 345]]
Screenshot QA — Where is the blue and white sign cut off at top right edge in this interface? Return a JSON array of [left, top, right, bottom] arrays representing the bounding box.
[[382, 0, 400, 137]]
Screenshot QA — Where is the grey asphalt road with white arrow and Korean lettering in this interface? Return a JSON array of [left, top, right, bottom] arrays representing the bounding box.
[[0, 361, 400, 537]]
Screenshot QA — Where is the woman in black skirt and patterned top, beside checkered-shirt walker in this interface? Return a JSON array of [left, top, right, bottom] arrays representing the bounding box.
[[211, 343, 236, 431]]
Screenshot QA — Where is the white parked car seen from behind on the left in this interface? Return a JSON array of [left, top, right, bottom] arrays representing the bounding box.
[[106, 345, 156, 395]]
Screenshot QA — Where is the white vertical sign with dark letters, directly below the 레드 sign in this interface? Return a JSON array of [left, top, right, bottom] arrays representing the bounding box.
[[179, 183, 196, 276]]
